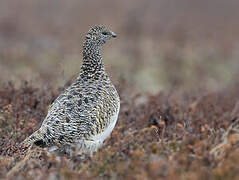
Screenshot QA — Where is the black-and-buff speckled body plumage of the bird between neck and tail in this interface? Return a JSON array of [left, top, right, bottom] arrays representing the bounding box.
[[41, 72, 119, 144]]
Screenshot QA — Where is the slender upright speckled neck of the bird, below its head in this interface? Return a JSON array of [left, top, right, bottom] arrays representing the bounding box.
[[81, 40, 104, 77]]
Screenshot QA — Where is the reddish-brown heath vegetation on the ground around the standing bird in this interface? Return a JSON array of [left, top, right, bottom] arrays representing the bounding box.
[[0, 82, 239, 180]]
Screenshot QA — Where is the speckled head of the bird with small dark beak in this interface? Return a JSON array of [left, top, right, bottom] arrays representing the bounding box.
[[85, 26, 116, 47]]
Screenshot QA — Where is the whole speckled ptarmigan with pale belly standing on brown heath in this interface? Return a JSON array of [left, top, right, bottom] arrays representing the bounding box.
[[22, 25, 120, 155]]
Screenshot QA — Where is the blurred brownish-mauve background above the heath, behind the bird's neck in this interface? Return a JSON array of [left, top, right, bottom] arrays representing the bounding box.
[[0, 0, 239, 93]]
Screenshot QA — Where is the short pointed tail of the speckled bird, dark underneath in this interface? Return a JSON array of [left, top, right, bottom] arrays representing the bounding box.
[[21, 130, 46, 147]]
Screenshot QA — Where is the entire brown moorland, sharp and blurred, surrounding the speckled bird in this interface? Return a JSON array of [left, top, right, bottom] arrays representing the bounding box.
[[0, 0, 239, 180]]
